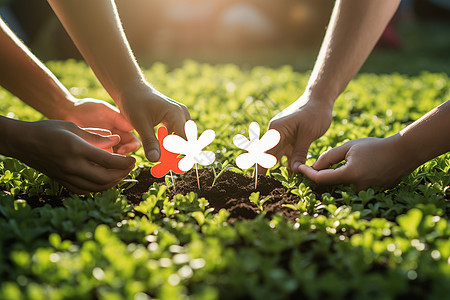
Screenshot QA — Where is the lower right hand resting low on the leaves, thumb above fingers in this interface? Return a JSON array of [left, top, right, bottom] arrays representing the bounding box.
[[299, 135, 417, 191]]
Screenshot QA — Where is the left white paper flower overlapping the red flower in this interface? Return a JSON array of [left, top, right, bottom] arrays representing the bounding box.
[[163, 120, 216, 171]]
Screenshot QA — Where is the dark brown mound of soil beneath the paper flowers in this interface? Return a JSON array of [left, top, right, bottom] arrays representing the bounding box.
[[123, 168, 299, 223]]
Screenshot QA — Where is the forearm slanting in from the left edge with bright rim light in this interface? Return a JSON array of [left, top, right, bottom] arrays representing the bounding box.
[[0, 19, 74, 118]]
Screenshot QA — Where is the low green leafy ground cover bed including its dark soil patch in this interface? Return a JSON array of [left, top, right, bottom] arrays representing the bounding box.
[[0, 61, 450, 299]]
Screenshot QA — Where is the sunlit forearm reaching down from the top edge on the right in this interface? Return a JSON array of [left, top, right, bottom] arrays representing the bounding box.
[[305, 0, 400, 103]]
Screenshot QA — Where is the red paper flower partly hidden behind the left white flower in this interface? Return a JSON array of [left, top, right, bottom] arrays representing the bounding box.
[[151, 126, 185, 178]]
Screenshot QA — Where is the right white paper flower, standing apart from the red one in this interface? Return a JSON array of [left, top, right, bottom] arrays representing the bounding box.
[[233, 122, 281, 169]]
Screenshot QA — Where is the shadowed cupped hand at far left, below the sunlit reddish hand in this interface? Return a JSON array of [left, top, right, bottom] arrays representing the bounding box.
[[5, 120, 135, 194]]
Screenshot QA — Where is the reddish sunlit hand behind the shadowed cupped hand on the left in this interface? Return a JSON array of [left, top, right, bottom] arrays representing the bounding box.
[[64, 98, 141, 154]]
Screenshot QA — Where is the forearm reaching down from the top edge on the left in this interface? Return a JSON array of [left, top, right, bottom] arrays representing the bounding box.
[[48, 0, 148, 107]]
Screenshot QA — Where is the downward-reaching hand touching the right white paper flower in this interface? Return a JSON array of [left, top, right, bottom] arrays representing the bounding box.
[[269, 96, 333, 172]]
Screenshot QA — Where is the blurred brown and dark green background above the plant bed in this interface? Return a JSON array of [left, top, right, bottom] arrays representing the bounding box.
[[0, 0, 450, 74]]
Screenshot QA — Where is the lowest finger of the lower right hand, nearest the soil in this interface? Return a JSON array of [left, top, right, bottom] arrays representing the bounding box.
[[298, 165, 350, 185]]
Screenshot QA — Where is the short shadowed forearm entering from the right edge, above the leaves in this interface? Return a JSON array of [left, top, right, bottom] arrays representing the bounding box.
[[397, 100, 450, 169]]
